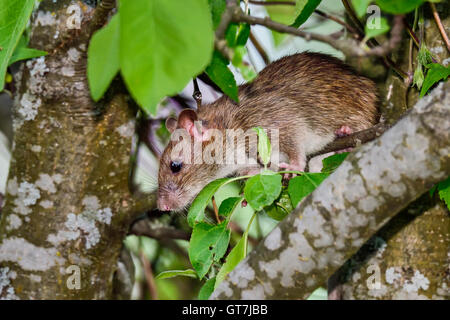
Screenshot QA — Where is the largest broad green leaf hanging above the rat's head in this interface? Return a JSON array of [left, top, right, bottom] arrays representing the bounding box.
[[119, 0, 214, 114]]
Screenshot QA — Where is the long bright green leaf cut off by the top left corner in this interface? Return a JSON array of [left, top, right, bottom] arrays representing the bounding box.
[[0, 0, 34, 91]]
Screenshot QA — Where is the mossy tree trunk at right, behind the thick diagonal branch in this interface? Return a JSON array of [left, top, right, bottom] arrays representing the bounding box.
[[333, 4, 450, 299]]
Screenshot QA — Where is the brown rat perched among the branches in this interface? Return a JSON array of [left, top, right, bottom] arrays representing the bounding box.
[[158, 52, 378, 211]]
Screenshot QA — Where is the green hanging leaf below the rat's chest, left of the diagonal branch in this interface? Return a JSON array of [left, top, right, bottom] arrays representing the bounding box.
[[189, 222, 230, 279]]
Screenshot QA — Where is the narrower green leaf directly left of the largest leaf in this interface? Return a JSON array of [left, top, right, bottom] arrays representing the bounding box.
[[87, 14, 120, 101]]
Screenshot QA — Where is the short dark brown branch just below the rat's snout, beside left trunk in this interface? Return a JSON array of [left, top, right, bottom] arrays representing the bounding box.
[[128, 219, 191, 241]]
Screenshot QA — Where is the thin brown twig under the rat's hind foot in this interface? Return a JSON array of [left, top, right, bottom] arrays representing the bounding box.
[[309, 123, 390, 158]]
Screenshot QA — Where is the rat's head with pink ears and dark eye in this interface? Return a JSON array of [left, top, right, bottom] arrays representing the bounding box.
[[157, 110, 219, 211]]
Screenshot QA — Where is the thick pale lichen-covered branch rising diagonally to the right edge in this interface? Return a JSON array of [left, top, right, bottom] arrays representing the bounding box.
[[211, 82, 450, 299]]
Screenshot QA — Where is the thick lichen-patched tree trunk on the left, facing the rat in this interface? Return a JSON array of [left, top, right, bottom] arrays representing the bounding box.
[[0, 0, 153, 299]]
